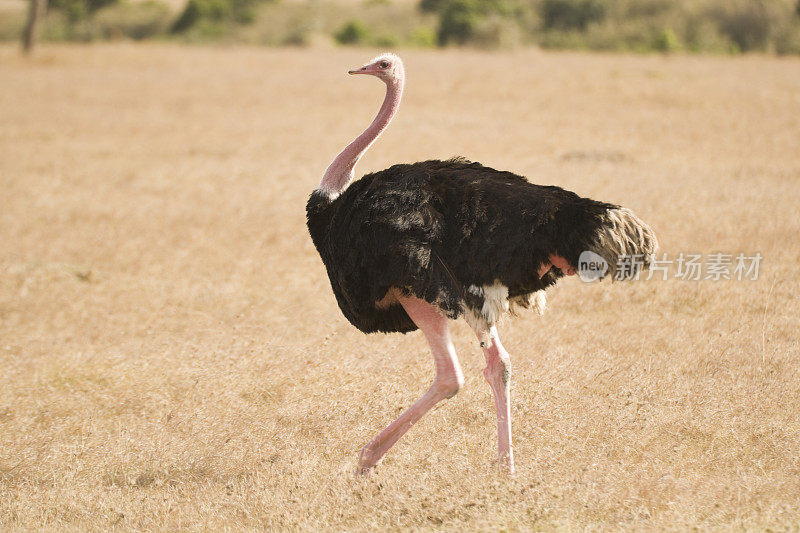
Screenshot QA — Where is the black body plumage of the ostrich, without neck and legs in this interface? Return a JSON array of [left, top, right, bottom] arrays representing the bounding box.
[[307, 158, 644, 333]]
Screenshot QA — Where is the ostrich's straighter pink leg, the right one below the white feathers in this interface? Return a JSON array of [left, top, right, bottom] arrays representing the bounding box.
[[474, 326, 514, 474]]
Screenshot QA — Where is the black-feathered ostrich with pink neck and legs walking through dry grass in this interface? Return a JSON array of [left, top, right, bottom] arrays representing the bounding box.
[[306, 54, 657, 473]]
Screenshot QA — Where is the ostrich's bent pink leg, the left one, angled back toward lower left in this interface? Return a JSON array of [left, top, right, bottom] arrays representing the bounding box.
[[358, 295, 464, 473]]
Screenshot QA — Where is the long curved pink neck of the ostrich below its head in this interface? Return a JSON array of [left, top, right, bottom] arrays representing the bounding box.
[[317, 78, 403, 199]]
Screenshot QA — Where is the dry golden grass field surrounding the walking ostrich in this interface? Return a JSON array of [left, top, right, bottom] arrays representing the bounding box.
[[0, 44, 800, 530]]
